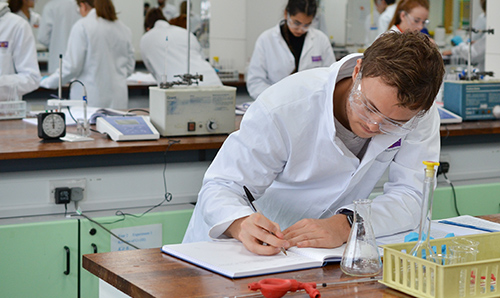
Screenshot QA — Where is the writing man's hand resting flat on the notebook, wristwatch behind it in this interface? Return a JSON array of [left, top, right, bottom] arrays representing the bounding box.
[[283, 214, 351, 248]]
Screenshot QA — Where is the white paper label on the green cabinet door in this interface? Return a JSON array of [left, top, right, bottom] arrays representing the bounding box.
[[110, 224, 162, 251]]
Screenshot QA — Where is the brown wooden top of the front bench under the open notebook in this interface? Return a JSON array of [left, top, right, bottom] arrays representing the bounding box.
[[82, 214, 500, 298]]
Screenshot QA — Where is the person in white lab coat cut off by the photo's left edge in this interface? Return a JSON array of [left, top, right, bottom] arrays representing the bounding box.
[[0, 2, 40, 100]]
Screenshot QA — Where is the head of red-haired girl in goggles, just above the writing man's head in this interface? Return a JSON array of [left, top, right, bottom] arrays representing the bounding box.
[[389, 0, 429, 33]]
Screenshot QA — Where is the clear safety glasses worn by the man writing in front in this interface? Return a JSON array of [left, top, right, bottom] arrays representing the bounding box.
[[349, 72, 423, 136]]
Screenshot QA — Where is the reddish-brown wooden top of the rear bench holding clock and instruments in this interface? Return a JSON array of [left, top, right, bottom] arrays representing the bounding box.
[[0, 116, 500, 160]]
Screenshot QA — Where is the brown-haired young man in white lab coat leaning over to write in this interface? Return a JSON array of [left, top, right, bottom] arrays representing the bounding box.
[[184, 32, 444, 255]]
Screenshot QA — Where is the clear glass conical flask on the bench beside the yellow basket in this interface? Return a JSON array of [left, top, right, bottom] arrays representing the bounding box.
[[340, 199, 382, 276]]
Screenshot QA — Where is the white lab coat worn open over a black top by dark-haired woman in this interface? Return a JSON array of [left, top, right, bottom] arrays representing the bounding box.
[[246, 24, 335, 99]]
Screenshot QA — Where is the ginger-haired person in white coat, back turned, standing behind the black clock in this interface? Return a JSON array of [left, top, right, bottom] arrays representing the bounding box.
[[40, 0, 135, 109]]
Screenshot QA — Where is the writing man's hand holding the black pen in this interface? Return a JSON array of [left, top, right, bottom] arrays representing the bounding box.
[[224, 213, 290, 255]]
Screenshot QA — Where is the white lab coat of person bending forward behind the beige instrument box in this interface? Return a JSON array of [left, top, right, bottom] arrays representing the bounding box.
[[140, 20, 222, 86]]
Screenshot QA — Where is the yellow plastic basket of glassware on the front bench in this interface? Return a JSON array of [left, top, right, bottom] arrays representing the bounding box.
[[380, 232, 500, 298]]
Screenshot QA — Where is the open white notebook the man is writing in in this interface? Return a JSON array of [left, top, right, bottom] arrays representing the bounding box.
[[161, 240, 345, 278]]
